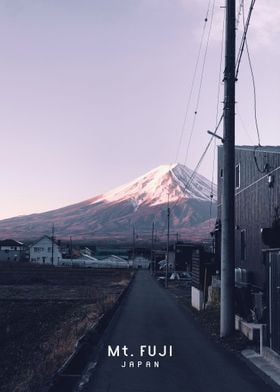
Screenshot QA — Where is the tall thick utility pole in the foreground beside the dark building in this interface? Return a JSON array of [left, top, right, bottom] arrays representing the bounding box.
[[220, 0, 236, 337]]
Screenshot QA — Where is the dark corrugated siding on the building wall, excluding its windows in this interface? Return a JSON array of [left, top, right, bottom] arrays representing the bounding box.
[[218, 147, 280, 287]]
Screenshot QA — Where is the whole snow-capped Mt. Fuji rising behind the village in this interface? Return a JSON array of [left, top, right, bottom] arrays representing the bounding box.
[[0, 164, 216, 242]]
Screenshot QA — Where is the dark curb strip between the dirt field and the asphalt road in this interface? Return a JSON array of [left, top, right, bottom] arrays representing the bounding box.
[[47, 272, 135, 392]]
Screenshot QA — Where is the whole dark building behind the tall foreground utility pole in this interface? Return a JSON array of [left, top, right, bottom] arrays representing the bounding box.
[[218, 146, 280, 354]]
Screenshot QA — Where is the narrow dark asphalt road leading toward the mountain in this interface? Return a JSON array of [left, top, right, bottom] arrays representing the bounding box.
[[83, 271, 278, 392]]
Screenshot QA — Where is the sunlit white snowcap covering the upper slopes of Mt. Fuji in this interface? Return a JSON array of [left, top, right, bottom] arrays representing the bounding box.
[[92, 164, 216, 210]]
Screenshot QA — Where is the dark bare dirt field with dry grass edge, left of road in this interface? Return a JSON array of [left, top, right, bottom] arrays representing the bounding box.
[[0, 265, 132, 392]]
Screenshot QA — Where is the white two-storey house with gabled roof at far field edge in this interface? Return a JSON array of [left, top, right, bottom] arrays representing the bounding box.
[[30, 235, 62, 265]]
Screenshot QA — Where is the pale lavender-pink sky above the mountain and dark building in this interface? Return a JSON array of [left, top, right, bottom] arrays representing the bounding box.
[[0, 0, 280, 218]]
